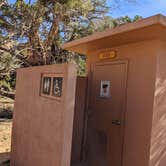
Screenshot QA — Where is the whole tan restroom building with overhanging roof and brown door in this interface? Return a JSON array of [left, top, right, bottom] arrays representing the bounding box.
[[63, 15, 166, 166]]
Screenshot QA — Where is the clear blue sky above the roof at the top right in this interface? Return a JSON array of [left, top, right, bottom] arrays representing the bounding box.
[[9, 0, 166, 17]]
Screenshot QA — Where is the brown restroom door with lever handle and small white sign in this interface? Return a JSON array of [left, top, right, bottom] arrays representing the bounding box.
[[87, 61, 127, 166]]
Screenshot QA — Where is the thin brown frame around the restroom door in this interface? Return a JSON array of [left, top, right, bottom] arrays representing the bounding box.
[[83, 59, 129, 166]]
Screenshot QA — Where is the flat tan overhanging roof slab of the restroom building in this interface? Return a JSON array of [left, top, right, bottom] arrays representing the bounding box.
[[62, 14, 166, 55]]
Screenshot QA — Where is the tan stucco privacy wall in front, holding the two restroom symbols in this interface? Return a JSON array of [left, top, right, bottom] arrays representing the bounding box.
[[11, 64, 76, 166]]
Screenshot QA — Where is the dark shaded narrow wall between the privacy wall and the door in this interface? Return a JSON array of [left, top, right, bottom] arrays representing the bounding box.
[[72, 77, 87, 163]]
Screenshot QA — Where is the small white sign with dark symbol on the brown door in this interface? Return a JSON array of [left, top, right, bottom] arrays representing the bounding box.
[[100, 80, 110, 98]]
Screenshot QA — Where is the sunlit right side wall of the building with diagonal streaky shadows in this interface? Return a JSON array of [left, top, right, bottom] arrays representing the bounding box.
[[150, 42, 166, 166]]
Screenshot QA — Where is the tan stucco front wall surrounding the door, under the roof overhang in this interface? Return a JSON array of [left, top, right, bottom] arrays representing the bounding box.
[[87, 40, 160, 166]]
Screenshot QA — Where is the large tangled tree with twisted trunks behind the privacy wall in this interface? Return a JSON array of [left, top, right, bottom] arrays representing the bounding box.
[[0, 0, 108, 98]]
